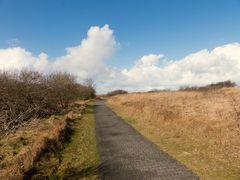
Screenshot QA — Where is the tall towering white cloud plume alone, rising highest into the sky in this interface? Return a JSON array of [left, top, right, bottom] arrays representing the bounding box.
[[53, 25, 116, 78]]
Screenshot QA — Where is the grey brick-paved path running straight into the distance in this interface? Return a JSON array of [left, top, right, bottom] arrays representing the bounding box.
[[95, 101, 198, 180]]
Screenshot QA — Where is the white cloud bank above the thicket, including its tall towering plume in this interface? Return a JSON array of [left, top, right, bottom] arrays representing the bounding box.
[[0, 25, 116, 79]]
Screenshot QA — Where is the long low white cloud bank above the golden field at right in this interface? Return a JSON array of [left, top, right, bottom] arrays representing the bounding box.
[[102, 43, 240, 91]]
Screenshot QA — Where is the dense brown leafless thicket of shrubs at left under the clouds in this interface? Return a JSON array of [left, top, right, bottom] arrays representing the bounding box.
[[0, 71, 95, 131]]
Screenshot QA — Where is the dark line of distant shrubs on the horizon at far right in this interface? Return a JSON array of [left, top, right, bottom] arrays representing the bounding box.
[[179, 80, 236, 91]]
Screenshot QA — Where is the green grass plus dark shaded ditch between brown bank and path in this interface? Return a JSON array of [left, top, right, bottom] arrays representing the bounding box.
[[28, 102, 99, 179]]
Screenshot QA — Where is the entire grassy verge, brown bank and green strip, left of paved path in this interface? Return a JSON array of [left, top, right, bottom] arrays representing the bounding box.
[[0, 102, 98, 179]]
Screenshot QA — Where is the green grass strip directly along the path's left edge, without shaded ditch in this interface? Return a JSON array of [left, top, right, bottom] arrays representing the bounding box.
[[56, 103, 99, 179]]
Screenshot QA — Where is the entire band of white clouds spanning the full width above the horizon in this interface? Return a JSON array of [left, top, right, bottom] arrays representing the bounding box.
[[0, 25, 240, 92]]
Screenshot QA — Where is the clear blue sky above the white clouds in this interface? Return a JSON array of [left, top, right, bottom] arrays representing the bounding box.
[[0, 0, 240, 90]]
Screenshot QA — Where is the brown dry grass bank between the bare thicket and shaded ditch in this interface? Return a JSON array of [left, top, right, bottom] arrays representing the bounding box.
[[0, 101, 84, 179]]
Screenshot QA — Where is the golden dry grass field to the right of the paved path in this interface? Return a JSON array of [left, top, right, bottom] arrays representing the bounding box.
[[107, 87, 240, 179]]
